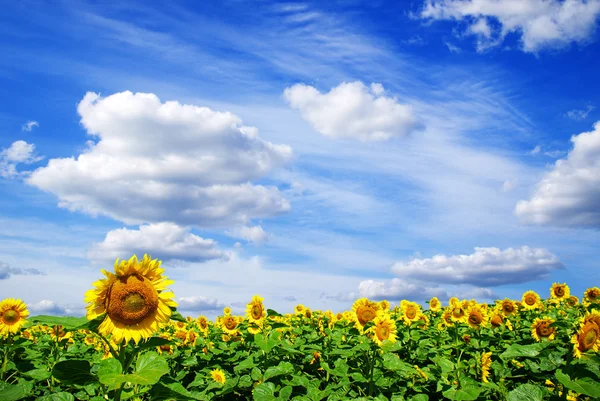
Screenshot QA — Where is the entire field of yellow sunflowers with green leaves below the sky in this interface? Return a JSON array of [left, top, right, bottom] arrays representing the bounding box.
[[0, 255, 600, 401]]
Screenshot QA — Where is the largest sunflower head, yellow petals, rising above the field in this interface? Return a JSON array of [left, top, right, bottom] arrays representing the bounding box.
[[85, 255, 177, 344]]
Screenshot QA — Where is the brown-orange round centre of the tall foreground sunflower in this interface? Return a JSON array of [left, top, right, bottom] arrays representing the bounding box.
[[106, 276, 158, 326]]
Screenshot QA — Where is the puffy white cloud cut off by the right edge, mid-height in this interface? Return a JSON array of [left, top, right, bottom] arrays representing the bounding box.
[[515, 121, 600, 229]]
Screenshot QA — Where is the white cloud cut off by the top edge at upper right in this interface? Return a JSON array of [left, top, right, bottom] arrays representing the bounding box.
[[420, 0, 600, 52]]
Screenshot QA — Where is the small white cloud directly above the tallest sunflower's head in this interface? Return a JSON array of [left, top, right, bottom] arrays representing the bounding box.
[[88, 223, 229, 262]]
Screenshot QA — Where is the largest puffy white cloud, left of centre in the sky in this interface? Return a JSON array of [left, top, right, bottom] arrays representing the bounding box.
[[27, 92, 292, 227]]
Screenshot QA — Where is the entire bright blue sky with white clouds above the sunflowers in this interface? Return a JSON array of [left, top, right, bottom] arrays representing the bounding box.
[[0, 0, 600, 316]]
